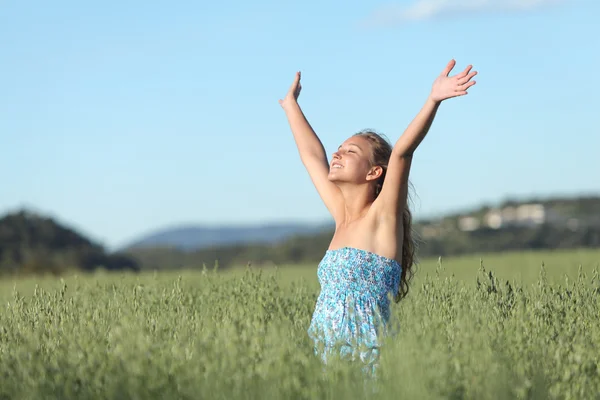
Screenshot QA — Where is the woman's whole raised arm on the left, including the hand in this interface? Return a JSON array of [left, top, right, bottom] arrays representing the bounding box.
[[279, 72, 344, 221]]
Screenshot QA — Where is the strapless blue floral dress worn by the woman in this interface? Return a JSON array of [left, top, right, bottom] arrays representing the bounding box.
[[308, 247, 402, 371]]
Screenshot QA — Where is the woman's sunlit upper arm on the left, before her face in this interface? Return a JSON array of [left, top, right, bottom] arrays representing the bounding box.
[[302, 156, 344, 221]]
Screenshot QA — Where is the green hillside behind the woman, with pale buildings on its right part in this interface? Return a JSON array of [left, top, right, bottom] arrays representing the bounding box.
[[128, 197, 600, 269]]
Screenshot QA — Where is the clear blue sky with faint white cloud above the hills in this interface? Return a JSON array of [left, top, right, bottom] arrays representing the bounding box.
[[0, 0, 600, 248]]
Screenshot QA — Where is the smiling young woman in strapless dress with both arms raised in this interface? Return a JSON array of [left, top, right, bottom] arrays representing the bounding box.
[[279, 60, 477, 372]]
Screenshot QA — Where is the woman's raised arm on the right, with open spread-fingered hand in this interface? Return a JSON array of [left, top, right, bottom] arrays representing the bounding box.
[[376, 60, 477, 217]]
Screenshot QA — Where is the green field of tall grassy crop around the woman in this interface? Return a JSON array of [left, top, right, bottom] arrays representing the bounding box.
[[0, 250, 600, 399]]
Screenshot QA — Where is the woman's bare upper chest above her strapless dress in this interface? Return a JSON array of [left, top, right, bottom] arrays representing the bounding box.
[[329, 207, 404, 264]]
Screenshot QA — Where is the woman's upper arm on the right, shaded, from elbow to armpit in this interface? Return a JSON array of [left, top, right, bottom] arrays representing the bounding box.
[[375, 151, 412, 217]]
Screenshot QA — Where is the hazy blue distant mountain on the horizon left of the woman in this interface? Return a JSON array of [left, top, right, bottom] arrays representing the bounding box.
[[124, 223, 331, 251]]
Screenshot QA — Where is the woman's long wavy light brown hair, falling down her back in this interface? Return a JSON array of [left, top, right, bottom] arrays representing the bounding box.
[[354, 130, 417, 302]]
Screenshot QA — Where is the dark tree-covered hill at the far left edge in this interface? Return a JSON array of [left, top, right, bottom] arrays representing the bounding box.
[[0, 210, 139, 274]]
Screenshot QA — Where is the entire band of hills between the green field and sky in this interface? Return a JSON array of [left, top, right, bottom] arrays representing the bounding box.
[[0, 196, 600, 274]]
